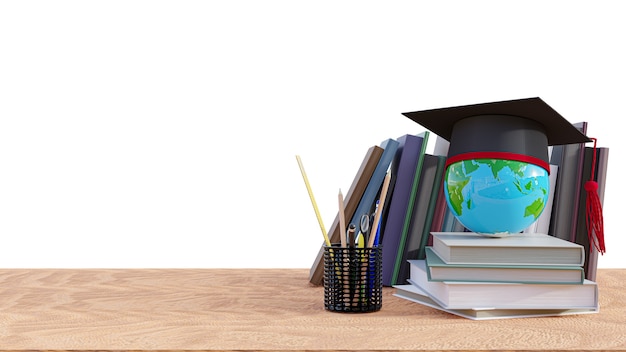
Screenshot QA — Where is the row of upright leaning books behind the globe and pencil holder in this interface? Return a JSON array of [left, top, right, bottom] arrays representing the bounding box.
[[309, 122, 609, 286]]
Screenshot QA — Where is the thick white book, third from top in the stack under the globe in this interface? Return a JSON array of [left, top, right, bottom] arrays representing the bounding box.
[[409, 260, 598, 309]]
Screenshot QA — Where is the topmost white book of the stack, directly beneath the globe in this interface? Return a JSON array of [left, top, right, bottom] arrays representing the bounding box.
[[432, 232, 585, 266]]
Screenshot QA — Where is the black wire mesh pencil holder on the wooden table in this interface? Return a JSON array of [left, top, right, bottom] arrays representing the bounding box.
[[324, 245, 383, 313]]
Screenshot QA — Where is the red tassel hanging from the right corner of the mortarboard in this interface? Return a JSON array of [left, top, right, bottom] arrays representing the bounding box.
[[585, 138, 606, 254]]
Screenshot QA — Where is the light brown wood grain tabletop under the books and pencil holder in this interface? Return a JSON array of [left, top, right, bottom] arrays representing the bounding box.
[[0, 269, 626, 351]]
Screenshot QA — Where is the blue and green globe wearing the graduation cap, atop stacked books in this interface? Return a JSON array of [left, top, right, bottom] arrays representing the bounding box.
[[444, 159, 550, 237]]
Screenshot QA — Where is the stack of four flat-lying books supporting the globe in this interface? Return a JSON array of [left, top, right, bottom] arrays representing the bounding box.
[[393, 232, 600, 320]]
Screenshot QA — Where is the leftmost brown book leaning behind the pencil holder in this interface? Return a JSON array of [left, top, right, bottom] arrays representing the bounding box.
[[309, 145, 383, 285]]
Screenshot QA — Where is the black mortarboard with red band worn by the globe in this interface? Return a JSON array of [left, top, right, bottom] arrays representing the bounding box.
[[403, 98, 591, 172]]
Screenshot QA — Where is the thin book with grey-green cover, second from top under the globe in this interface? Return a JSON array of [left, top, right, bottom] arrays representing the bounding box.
[[426, 247, 585, 284]]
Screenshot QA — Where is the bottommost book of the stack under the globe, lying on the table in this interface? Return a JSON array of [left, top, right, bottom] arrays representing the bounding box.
[[393, 284, 600, 320]]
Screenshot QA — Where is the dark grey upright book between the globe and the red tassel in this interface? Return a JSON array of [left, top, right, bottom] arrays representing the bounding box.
[[548, 122, 587, 242]]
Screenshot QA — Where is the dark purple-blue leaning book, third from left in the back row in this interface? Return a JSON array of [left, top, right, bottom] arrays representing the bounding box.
[[381, 131, 429, 286]]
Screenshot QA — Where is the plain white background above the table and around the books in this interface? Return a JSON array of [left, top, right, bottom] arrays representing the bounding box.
[[0, 0, 626, 268]]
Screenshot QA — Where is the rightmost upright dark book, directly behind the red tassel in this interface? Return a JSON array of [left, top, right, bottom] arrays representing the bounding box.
[[575, 147, 608, 280]]
